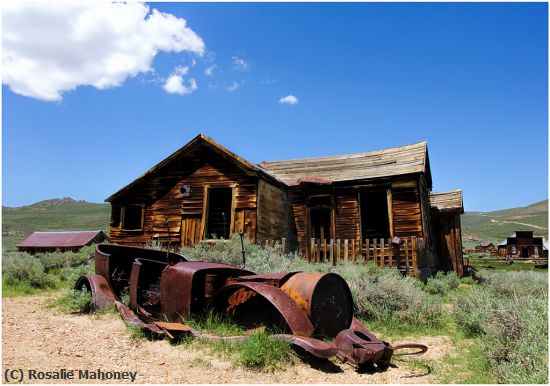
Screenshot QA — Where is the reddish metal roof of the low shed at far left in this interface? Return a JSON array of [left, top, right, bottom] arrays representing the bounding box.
[[17, 231, 107, 248]]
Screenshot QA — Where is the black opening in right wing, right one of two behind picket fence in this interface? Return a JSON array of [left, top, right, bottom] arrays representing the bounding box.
[[359, 190, 390, 239]]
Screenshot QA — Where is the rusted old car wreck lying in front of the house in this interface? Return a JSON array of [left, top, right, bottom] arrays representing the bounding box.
[[76, 244, 428, 368]]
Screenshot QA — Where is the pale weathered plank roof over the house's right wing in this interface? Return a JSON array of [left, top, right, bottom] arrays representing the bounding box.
[[259, 141, 432, 187]]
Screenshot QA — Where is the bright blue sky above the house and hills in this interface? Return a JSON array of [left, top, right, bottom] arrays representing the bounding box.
[[2, 3, 548, 211]]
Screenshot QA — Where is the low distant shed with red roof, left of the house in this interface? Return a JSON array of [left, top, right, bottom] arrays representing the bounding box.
[[17, 231, 108, 254]]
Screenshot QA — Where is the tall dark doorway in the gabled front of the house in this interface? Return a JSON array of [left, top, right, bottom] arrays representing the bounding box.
[[205, 188, 233, 239]]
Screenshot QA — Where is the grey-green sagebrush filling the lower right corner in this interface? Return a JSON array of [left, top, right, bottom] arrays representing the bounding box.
[[452, 272, 548, 383]]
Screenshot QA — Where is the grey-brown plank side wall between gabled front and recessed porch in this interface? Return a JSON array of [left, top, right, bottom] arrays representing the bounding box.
[[257, 179, 289, 242]]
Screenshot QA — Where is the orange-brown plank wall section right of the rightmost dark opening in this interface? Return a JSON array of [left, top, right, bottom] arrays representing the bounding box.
[[391, 180, 424, 238]]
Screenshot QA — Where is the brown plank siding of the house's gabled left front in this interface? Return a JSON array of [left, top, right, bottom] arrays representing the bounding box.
[[110, 147, 258, 245]]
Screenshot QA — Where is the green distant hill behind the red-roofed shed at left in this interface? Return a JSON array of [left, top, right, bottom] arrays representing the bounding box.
[[2, 197, 111, 251]]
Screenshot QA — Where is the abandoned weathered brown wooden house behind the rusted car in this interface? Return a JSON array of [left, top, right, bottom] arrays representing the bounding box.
[[106, 134, 463, 274]]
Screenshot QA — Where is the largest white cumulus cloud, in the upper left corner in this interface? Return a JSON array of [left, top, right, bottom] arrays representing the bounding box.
[[2, 0, 205, 101]]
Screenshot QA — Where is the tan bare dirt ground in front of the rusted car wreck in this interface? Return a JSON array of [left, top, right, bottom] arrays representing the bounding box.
[[2, 296, 450, 383]]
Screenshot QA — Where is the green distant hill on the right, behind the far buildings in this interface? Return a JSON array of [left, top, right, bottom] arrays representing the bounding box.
[[462, 200, 548, 242]]
